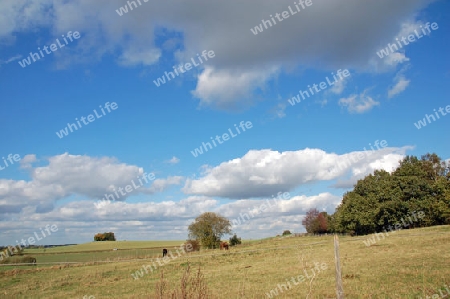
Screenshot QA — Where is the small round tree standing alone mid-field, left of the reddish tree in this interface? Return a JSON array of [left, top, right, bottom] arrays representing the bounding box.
[[188, 212, 231, 249]]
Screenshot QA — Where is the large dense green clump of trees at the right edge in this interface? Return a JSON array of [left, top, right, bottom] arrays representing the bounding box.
[[333, 154, 450, 234]]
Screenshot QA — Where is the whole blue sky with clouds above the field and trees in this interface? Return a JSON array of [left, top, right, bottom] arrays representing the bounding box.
[[0, 0, 450, 245]]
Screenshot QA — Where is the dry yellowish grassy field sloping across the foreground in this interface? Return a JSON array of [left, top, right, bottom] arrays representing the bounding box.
[[0, 226, 450, 299]]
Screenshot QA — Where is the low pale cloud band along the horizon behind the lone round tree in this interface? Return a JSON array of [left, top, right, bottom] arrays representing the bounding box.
[[0, 193, 341, 244]]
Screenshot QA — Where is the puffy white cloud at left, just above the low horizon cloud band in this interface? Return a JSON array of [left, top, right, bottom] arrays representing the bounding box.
[[0, 153, 183, 213]]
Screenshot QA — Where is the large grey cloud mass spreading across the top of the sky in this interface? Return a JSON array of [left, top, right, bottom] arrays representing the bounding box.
[[0, 0, 433, 110]]
